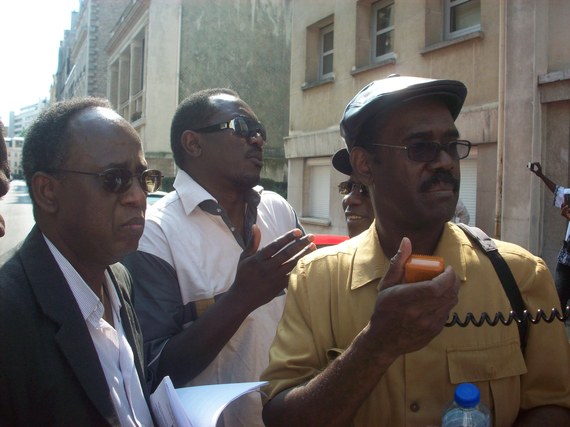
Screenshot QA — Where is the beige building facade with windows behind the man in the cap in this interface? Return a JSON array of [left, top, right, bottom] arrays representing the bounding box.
[[285, 0, 570, 267]]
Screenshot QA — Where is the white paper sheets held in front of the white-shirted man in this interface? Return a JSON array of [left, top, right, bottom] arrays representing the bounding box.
[[150, 377, 267, 427]]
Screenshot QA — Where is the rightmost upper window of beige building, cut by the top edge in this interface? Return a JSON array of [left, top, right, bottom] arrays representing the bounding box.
[[445, 0, 481, 40]]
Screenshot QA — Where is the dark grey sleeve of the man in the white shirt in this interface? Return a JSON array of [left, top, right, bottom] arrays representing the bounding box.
[[123, 251, 191, 390]]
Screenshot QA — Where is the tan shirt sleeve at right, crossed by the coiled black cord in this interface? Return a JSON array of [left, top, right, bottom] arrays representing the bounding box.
[[513, 251, 570, 410]]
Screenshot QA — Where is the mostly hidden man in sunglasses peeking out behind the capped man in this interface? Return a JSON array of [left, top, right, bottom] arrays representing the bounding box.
[[332, 148, 374, 237]]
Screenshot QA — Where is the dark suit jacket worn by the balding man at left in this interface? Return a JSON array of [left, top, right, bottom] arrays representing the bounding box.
[[0, 227, 148, 426]]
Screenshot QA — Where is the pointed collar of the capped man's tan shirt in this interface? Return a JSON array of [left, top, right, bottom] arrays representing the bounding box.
[[350, 222, 472, 289]]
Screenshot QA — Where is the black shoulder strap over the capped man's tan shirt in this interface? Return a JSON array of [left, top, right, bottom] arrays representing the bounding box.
[[457, 223, 527, 352]]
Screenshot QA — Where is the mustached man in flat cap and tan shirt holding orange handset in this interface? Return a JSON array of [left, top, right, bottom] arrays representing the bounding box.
[[262, 76, 570, 427]]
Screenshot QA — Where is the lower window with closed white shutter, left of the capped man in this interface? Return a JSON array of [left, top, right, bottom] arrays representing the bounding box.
[[303, 158, 331, 220]]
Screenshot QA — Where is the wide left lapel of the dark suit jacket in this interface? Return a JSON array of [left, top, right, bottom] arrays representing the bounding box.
[[20, 226, 119, 425]]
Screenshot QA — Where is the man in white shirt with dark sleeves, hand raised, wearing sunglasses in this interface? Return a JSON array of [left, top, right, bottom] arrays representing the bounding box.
[[125, 89, 314, 427]]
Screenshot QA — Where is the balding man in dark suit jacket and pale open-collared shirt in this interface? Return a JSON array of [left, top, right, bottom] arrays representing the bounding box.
[[0, 98, 156, 426]]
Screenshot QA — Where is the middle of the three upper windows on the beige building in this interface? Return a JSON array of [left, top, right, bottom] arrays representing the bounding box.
[[371, 1, 394, 62]]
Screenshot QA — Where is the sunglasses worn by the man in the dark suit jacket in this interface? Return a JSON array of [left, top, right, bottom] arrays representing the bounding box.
[[48, 168, 162, 193]]
